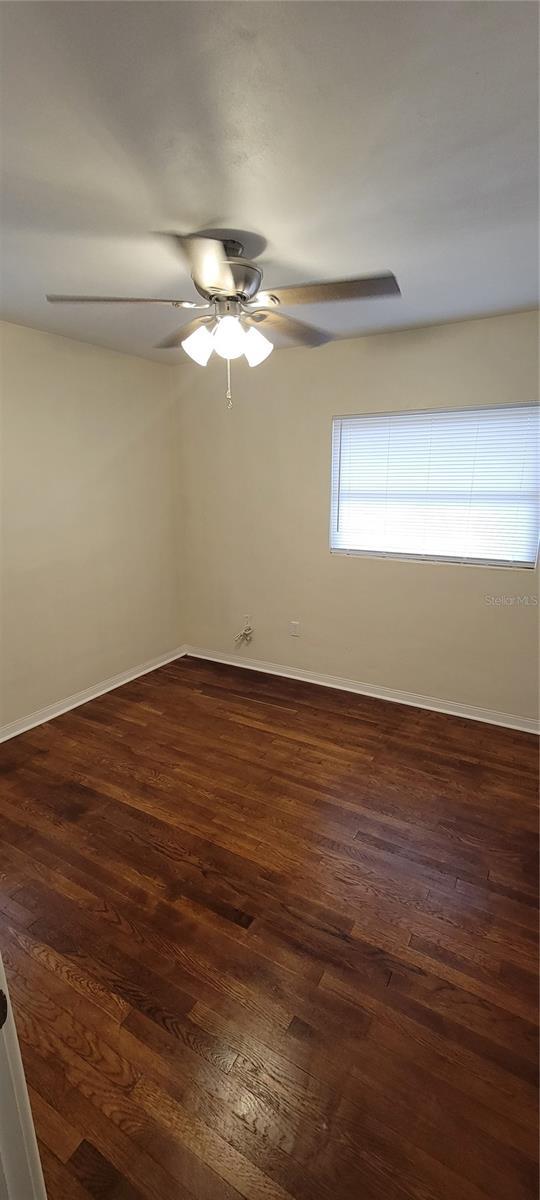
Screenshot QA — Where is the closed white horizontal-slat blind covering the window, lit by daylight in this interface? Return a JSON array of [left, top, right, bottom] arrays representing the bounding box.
[[330, 404, 539, 566]]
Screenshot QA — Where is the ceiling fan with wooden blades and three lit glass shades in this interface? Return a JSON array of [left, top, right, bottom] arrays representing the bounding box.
[[47, 233, 401, 367]]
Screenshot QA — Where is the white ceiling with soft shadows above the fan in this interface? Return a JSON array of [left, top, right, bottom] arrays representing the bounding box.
[[0, 0, 538, 361]]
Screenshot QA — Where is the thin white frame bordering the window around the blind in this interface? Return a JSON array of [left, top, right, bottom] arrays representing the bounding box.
[[329, 400, 540, 571]]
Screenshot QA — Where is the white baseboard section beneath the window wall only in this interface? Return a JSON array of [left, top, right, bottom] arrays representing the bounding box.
[[184, 646, 540, 733]]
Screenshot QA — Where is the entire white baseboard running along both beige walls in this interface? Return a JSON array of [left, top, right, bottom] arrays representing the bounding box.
[[0, 646, 540, 742]]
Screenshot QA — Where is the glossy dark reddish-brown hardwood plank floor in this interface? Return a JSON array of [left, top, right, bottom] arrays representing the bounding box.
[[0, 659, 538, 1200]]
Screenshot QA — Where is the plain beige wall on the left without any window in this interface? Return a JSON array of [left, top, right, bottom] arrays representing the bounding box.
[[0, 325, 180, 724]]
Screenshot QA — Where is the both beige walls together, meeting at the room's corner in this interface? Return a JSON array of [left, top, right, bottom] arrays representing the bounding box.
[[0, 313, 539, 724]]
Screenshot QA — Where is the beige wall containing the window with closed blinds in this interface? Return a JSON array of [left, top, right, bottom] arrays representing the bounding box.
[[178, 313, 538, 718]]
